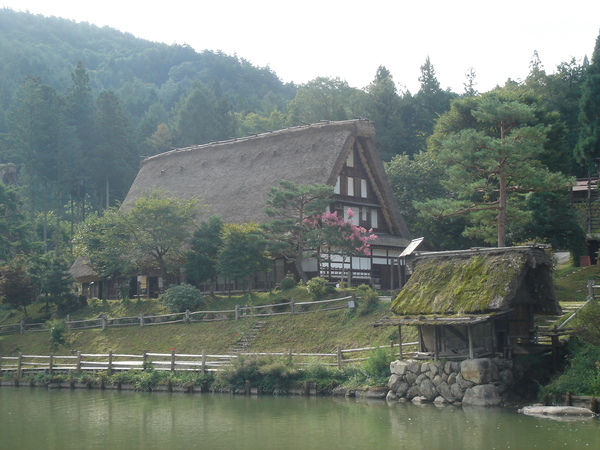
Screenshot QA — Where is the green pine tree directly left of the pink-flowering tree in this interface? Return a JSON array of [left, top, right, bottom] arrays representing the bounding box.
[[265, 180, 333, 281]]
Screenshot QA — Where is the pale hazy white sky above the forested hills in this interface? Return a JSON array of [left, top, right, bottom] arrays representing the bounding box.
[[0, 0, 600, 93]]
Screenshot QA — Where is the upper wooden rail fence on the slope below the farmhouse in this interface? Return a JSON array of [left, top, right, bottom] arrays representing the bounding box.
[[0, 296, 354, 334]]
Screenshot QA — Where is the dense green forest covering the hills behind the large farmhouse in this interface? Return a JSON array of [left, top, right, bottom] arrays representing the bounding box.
[[0, 9, 600, 288]]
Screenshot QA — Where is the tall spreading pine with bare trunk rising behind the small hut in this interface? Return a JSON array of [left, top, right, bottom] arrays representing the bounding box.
[[417, 96, 570, 247]]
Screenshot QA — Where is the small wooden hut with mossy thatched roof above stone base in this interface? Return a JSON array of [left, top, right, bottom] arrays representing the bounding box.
[[377, 246, 560, 358]]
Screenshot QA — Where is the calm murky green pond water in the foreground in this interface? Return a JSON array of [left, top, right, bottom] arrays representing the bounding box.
[[0, 387, 600, 450]]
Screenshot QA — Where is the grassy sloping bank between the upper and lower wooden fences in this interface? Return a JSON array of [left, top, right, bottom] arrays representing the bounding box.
[[0, 302, 408, 356]]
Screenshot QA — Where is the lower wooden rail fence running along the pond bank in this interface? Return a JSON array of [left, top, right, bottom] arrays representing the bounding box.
[[0, 342, 418, 379]]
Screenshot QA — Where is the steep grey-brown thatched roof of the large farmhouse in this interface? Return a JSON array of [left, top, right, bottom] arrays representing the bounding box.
[[123, 120, 409, 238]]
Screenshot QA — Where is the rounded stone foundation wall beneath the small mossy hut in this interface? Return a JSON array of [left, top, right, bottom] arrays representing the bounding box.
[[386, 358, 514, 406]]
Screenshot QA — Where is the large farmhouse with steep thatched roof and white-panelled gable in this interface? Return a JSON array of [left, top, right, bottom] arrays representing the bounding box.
[[74, 119, 410, 296]]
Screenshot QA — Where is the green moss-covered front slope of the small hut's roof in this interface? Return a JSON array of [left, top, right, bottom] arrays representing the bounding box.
[[392, 252, 527, 314]]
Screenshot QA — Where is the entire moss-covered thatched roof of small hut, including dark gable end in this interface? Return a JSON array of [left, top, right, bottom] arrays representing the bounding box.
[[392, 247, 560, 315]]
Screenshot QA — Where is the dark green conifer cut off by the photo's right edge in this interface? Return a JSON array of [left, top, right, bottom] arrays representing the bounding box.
[[575, 35, 600, 173]]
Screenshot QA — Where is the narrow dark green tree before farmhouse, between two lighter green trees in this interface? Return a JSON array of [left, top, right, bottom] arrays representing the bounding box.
[[185, 216, 224, 293]]
